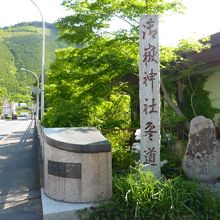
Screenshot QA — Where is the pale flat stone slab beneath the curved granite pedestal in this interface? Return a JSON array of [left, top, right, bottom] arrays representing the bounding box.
[[41, 188, 95, 220]]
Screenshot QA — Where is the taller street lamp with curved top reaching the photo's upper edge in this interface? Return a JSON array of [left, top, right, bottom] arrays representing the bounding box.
[[30, 0, 45, 119]]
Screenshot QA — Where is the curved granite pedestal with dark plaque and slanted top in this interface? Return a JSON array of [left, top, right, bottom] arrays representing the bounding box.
[[44, 128, 112, 203]]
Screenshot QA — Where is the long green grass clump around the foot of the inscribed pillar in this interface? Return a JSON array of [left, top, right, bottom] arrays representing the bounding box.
[[90, 168, 220, 220]]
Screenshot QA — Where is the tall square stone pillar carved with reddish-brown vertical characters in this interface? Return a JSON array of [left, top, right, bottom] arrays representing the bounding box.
[[139, 15, 161, 177]]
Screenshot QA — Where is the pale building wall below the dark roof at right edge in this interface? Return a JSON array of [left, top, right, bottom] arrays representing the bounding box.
[[205, 71, 220, 124]]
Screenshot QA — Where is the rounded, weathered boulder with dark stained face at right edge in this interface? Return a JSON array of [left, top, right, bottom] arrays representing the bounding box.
[[183, 116, 220, 182]]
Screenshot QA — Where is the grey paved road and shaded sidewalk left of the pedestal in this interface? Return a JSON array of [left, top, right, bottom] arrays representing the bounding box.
[[0, 120, 42, 220]]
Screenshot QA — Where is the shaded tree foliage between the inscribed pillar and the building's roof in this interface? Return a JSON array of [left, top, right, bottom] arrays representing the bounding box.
[[161, 38, 218, 120]]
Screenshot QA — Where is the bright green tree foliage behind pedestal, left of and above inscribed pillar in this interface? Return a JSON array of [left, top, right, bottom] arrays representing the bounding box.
[[44, 0, 182, 127]]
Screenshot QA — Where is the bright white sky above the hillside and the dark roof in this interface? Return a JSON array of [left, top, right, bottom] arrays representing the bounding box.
[[0, 0, 220, 45]]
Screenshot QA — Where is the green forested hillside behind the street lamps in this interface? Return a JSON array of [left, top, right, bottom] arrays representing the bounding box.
[[0, 22, 63, 102]]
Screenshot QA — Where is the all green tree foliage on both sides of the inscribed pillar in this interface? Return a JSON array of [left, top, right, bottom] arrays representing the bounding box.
[[44, 0, 216, 144]]
